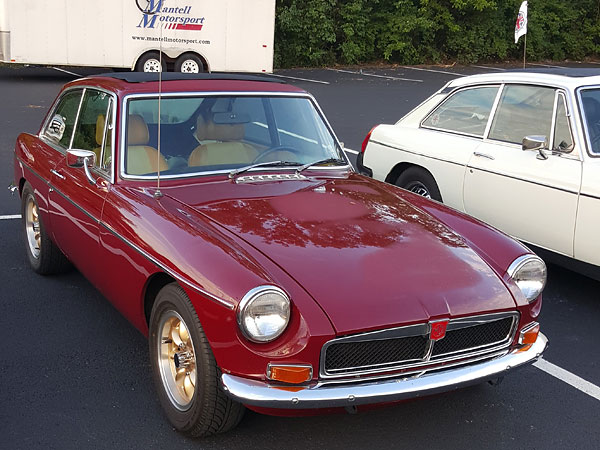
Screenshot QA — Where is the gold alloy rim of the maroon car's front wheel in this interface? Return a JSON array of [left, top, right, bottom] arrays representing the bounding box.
[[157, 310, 197, 411]]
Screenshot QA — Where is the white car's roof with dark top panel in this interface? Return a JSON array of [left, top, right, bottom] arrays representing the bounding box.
[[448, 67, 600, 89]]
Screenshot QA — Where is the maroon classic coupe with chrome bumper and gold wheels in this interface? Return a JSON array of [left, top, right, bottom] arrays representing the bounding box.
[[15, 73, 547, 436]]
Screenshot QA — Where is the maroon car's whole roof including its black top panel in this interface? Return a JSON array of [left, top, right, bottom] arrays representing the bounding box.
[[65, 72, 305, 95]]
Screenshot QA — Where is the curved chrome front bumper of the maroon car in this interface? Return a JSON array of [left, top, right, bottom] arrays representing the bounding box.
[[221, 333, 548, 409]]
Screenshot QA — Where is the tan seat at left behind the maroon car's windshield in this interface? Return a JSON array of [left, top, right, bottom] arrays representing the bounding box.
[[127, 114, 169, 175]]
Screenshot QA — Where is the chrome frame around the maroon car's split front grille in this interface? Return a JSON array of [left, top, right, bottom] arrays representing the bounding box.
[[319, 311, 519, 379]]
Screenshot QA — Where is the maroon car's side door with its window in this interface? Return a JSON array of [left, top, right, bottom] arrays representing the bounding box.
[[49, 88, 114, 282]]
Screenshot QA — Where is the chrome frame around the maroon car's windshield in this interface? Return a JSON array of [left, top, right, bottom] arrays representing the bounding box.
[[119, 91, 354, 181]]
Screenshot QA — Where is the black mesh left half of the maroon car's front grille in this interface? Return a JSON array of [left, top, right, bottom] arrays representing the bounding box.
[[325, 336, 427, 372]]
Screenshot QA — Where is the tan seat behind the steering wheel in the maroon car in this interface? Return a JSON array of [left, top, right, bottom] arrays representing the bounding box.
[[188, 116, 258, 166]]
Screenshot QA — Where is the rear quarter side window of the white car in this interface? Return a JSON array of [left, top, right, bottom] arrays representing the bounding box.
[[421, 86, 498, 136]]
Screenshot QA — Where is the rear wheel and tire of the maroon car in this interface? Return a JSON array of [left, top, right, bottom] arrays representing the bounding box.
[[21, 182, 71, 275]]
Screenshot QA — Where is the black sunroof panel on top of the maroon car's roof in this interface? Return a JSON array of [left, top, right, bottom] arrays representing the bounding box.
[[94, 72, 286, 84]]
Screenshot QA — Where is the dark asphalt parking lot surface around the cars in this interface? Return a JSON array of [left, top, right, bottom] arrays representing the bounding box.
[[0, 64, 600, 449]]
